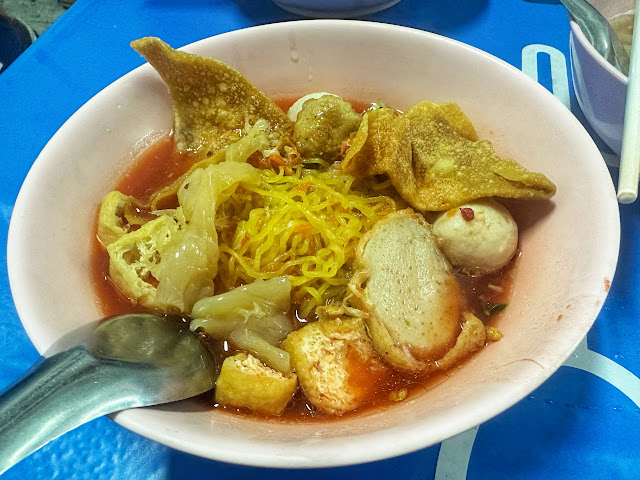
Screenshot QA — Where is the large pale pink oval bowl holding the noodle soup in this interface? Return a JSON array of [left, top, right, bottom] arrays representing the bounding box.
[[7, 20, 619, 467]]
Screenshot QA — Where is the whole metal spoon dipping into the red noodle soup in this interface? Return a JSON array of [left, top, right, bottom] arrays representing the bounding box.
[[0, 313, 217, 474]]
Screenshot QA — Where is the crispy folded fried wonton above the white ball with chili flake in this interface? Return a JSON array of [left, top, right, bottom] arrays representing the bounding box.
[[342, 101, 556, 211]]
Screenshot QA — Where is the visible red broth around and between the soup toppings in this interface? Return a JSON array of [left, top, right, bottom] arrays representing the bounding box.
[[92, 117, 517, 421]]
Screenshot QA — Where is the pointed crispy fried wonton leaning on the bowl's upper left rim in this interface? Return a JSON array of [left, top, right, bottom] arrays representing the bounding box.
[[131, 37, 291, 158]]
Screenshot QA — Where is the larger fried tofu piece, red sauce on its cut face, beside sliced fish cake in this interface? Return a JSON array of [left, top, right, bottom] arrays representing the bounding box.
[[282, 318, 388, 415]]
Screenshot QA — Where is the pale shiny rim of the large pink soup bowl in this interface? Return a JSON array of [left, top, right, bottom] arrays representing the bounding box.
[[7, 19, 620, 468]]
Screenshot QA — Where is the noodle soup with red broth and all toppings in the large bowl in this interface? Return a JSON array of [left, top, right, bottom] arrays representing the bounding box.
[[94, 38, 555, 416]]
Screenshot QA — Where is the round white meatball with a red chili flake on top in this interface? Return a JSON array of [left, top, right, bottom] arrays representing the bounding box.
[[433, 199, 518, 275]]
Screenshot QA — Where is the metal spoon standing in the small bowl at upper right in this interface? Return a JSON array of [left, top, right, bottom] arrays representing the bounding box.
[[560, 0, 629, 75]]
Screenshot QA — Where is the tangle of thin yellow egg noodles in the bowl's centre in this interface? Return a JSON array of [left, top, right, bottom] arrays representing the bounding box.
[[218, 166, 396, 317]]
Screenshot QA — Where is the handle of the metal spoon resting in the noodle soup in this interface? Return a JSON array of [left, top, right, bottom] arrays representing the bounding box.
[[0, 347, 145, 474]]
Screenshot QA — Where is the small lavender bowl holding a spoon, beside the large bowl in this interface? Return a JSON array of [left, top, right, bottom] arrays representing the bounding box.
[[569, 0, 635, 156]]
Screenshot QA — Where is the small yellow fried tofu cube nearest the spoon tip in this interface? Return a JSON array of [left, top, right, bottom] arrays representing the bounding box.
[[215, 353, 298, 415]]
